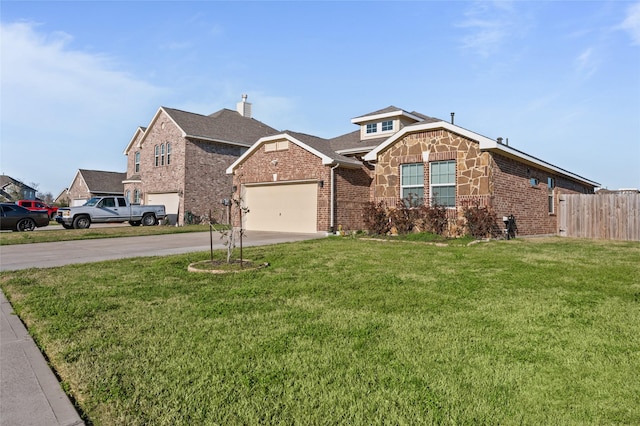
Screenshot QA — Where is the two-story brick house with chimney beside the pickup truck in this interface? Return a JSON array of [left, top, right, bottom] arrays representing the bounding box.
[[124, 95, 277, 225]]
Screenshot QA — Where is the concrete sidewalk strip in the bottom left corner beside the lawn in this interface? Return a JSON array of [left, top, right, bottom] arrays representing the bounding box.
[[0, 291, 84, 426]]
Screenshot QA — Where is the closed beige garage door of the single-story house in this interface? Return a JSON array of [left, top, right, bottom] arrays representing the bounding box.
[[244, 182, 318, 233]]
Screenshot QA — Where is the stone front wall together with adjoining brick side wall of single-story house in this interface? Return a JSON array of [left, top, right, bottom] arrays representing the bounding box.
[[373, 130, 593, 235]]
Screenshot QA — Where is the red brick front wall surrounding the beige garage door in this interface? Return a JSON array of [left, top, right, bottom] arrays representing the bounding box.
[[233, 142, 331, 231]]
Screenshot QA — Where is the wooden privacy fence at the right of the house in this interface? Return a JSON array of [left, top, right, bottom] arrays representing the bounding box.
[[558, 193, 640, 241]]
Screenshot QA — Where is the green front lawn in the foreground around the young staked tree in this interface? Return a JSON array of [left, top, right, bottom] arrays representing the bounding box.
[[0, 238, 640, 425]]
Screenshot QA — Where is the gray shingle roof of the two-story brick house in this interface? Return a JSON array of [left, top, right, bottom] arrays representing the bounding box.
[[163, 107, 279, 146]]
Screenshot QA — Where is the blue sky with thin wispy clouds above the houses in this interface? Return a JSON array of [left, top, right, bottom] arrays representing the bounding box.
[[0, 0, 640, 196]]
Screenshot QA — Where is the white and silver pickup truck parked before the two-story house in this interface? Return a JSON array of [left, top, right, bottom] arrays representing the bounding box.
[[55, 197, 167, 229]]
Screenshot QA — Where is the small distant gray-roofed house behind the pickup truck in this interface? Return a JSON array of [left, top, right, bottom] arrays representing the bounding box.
[[66, 169, 127, 206]]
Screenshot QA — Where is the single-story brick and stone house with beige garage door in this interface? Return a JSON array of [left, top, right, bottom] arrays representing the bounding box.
[[227, 107, 599, 235]]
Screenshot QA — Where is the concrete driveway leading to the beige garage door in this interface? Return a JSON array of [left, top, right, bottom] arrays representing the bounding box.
[[0, 231, 326, 271]]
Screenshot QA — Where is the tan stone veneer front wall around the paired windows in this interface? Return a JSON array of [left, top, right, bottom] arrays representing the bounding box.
[[373, 130, 492, 206]]
